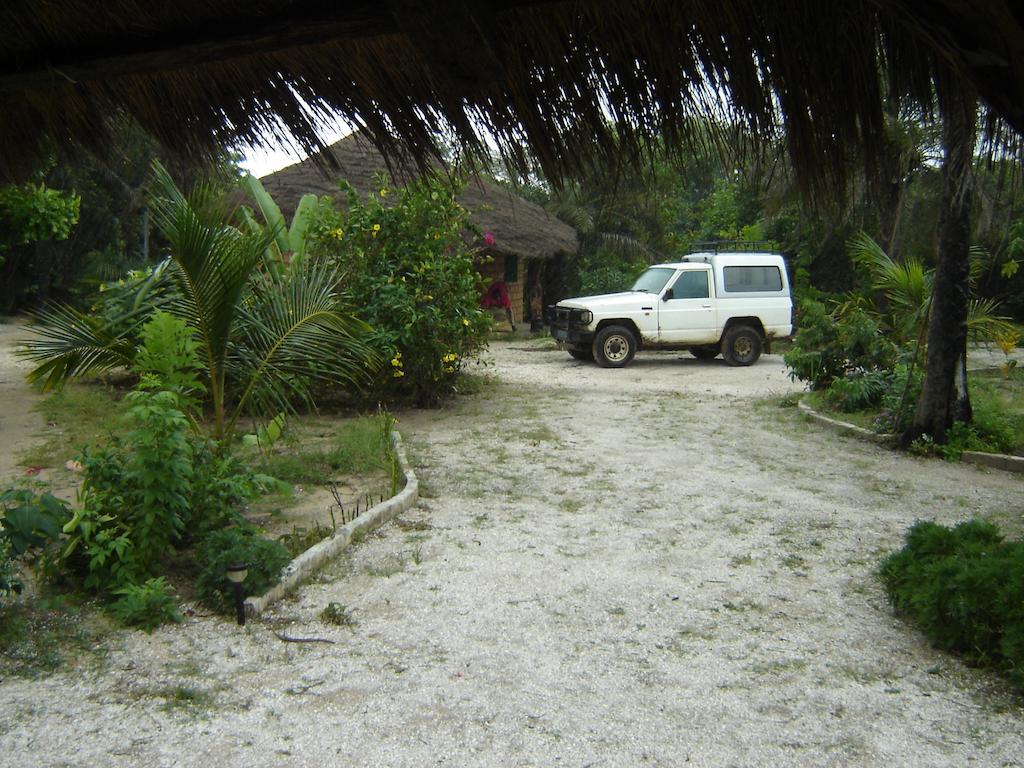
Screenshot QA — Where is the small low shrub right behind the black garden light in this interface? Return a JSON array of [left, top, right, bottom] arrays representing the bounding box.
[[196, 526, 291, 612]]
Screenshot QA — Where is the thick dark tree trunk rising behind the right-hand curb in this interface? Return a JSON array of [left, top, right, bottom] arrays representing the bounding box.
[[902, 84, 977, 444]]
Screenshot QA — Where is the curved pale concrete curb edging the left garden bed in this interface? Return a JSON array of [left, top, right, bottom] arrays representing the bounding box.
[[246, 430, 420, 616]]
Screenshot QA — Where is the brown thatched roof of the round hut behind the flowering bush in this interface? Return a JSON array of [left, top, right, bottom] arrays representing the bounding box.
[[260, 134, 579, 259]]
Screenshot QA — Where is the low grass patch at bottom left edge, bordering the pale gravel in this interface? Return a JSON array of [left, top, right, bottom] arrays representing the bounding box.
[[0, 597, 113, 679]]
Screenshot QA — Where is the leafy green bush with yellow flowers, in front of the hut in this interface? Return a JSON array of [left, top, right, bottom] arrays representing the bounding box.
[[307, 181, 491, 404]]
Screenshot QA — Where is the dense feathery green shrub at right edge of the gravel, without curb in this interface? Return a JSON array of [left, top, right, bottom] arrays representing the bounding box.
[[879, 520, 1024, 686]]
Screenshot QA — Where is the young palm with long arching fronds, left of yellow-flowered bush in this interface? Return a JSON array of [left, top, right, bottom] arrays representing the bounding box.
[[25, 163, 379, 440]]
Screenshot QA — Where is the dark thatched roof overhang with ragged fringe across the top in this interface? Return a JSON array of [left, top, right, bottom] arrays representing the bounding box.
[[0, 0, 1024, 185]]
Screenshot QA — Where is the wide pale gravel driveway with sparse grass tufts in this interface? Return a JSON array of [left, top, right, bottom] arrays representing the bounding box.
[[0, 344, 1024, 768]]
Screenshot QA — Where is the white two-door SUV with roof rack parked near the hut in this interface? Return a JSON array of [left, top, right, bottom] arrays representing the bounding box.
[[549, 252, 793, 368]]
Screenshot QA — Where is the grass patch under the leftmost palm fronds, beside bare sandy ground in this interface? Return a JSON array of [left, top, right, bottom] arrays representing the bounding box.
[[19, 382, 125, 467]]
